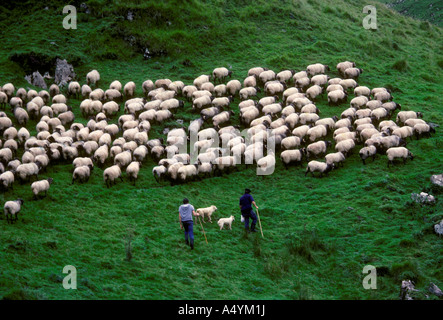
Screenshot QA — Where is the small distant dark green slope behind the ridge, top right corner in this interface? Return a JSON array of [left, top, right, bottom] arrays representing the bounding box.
[[381, 0, 443, 27]]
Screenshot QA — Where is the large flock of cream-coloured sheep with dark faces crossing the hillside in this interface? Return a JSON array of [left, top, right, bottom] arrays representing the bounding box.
[[0, 61, 435, 222]]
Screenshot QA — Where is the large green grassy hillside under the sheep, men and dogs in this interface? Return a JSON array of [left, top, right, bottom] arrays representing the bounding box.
[[0, 0, 443, 299]]
